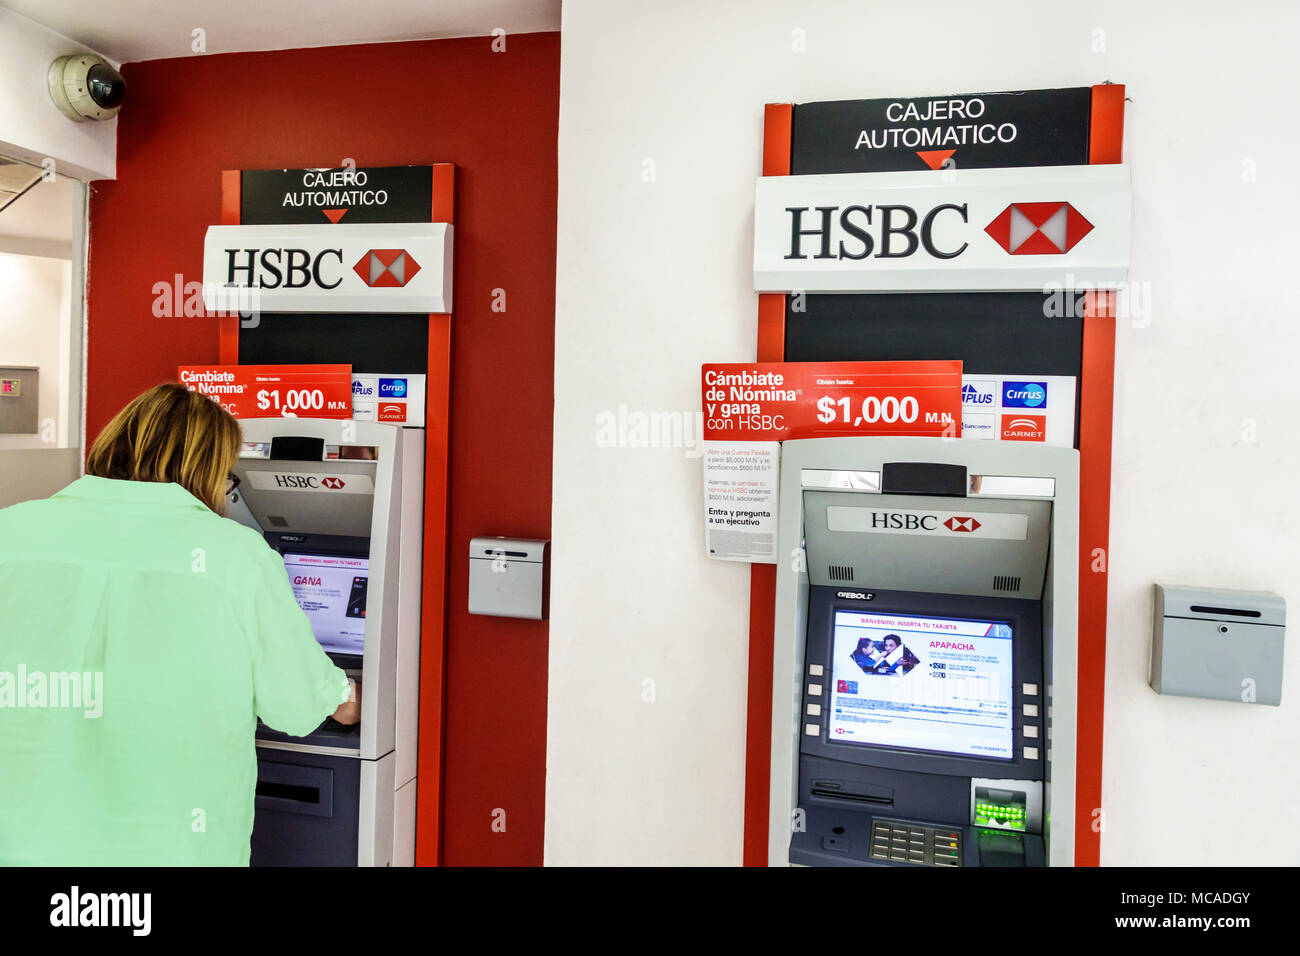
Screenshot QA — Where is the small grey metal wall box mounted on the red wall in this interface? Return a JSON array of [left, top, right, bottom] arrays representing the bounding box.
[[469, 537, 551, 620]]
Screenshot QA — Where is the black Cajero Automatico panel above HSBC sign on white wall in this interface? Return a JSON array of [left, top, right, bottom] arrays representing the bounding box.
[[790, 86, 1092, 176]]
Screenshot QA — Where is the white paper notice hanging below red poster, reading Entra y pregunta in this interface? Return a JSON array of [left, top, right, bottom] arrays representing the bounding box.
[[703, 441, 781, 564]]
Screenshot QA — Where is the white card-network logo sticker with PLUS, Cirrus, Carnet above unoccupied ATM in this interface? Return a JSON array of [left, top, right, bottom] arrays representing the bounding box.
[[962, 375, 1075, 447]]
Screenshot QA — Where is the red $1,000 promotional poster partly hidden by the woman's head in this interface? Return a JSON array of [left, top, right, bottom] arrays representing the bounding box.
[[177, 365, 352, 419]]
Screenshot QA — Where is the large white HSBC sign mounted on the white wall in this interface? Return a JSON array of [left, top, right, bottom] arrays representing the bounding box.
[[754, 165, 1130, 293]]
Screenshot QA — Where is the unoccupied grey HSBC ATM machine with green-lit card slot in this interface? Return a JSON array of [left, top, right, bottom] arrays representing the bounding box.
[[768, 437, 1079, 868]]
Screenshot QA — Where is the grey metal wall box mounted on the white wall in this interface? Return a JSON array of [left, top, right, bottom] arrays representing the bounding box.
[[1151, 584, 1287, 705]]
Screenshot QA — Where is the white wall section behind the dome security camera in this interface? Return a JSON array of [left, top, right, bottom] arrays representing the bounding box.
[[0, 8, 117, 179]]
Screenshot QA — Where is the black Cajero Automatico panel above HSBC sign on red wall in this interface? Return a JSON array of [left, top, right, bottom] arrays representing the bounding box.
[[239, 166, 433, 226]]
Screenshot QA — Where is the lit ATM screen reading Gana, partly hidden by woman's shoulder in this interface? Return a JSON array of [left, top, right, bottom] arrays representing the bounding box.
[[285, 554, 371, 656]]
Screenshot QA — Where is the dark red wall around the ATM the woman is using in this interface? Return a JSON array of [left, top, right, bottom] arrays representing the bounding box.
[[87, 34, 560, 865]]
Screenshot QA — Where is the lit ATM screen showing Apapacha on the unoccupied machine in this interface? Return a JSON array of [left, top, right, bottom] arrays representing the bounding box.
[[827, 610, 1014, 760]]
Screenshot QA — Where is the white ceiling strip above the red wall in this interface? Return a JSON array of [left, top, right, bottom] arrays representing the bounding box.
[[0, 0, 560, 62]]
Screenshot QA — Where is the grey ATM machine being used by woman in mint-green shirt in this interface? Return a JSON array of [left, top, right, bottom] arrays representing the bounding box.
[[229, 418, 424, 866]]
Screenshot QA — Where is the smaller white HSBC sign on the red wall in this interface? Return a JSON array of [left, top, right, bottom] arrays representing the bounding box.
[[203, 222, 452, 312]]
